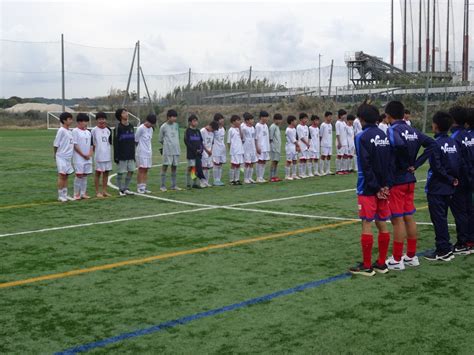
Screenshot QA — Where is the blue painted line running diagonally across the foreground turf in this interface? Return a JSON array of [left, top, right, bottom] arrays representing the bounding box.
[[56, 272, 351, 355]]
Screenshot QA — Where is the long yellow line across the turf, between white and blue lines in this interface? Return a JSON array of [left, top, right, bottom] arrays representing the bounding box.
[[0, 221, 359, 288]]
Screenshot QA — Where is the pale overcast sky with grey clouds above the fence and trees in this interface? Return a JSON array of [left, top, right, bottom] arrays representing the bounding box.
[[0, 0, 470, 97]]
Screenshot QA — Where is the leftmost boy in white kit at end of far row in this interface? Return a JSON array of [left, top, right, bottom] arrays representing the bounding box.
[[53, 112, 74, 202]]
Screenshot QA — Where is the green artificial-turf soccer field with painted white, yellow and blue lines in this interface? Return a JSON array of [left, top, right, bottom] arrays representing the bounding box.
[[0, 130, 474, 354]]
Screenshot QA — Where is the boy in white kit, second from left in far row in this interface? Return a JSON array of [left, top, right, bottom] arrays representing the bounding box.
[[72, 113, 94, 200]]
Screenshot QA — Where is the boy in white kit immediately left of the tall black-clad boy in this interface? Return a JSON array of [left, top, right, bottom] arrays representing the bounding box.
[[91, 112, 112, 198]]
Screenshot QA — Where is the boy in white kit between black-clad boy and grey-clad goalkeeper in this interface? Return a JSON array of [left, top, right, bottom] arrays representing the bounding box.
[[135, 113, 156, 194]]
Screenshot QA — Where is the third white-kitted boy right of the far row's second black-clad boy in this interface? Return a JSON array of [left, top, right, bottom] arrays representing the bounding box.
[[227, 115, 244, 185]]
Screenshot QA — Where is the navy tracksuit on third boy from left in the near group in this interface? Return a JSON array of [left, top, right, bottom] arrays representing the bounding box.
[[425, 133, 467, 254]]
